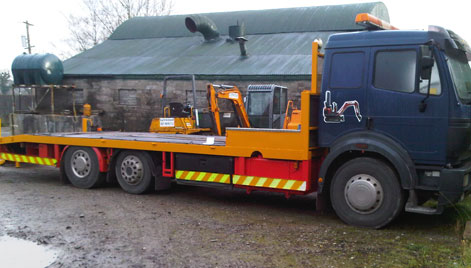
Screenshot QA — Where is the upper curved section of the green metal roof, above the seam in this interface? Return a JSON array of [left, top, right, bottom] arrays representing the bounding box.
[[110, 2, 389, 40]]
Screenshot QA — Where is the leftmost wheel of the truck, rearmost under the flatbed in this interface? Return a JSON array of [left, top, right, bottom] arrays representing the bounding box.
[[64, 147, 105, 189]]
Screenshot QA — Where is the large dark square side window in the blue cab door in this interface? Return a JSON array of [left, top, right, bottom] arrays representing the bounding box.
[[373, 50, 417, 93]]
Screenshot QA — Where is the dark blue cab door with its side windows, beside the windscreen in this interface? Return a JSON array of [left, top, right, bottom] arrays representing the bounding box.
[[367, 46, 448, 164]]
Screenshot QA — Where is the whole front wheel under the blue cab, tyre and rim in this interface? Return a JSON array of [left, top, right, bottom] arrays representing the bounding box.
[[330, 157, 404, 228]]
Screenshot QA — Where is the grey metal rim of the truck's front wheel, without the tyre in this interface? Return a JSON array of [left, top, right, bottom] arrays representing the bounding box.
[[345, 174, 383, 214]]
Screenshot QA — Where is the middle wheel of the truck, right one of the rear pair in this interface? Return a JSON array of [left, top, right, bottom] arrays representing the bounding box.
[[115, 151, 152, 194]]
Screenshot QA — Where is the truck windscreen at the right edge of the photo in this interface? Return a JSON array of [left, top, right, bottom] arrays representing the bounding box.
[[448, 53, 471, 104]]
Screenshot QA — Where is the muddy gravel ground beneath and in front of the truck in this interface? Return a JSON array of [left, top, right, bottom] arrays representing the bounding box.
[[0, 165, 468, 267]]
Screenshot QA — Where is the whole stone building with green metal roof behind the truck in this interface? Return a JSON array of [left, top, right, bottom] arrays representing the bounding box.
[[63, 2, 389, 131]]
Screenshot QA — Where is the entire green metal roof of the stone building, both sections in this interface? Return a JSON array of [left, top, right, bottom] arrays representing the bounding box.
[[64, 2, 389, 76]]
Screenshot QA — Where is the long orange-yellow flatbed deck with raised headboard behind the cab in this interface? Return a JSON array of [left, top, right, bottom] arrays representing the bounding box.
[[0, 91, 321, 161]]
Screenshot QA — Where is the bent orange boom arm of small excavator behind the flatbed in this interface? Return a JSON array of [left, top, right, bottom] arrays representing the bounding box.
[[207, 84, 250, 136]]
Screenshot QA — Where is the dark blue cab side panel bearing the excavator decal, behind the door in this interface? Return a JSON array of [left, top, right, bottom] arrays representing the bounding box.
[[319, 48, 370, 147]]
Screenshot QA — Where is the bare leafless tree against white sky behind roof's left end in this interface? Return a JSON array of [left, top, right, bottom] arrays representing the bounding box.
[[68, 0, 173, 51]]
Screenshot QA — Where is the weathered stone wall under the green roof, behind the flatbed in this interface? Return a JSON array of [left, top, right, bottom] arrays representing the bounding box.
[[61, 78, 310, 131]]
